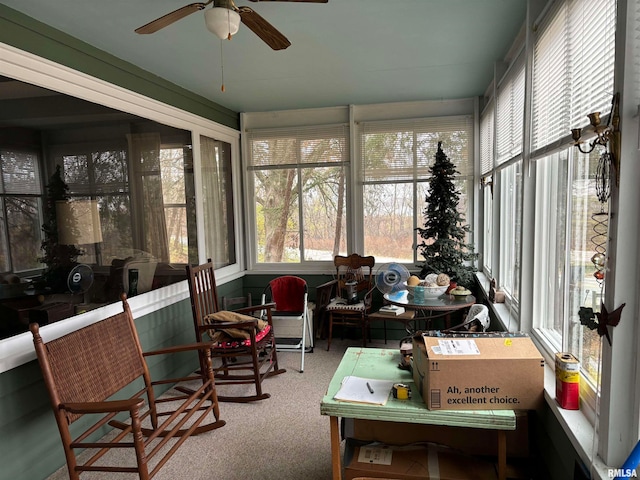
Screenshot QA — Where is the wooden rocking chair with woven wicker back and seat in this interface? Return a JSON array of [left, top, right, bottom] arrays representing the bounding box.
[[29, 295, 225, 480]]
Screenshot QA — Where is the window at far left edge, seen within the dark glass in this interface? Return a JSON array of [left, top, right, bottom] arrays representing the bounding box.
[[0, 148, 42, 273]]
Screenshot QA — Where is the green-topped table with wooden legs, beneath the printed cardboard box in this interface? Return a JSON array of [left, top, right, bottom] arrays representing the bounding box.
[[320, 347, 516, 480]]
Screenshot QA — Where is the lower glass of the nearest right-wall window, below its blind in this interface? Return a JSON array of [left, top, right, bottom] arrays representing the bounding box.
[[534, 150, 608, 402]]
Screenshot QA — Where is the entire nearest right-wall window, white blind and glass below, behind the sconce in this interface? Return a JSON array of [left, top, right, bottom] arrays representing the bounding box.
[[531, 0, 616, 407]]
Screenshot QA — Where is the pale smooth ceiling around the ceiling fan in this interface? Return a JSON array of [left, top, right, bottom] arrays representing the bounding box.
[[2, 0, 526, 112]]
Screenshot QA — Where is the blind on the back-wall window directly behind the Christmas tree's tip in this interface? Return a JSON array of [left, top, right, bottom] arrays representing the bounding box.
[[359, 115, 473, 182]]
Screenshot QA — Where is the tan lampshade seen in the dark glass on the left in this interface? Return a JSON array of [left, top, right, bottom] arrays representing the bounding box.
[[56, 200, 102, 245]]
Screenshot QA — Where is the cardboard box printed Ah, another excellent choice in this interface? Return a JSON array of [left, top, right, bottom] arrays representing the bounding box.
[[412, 332, 544, 410]]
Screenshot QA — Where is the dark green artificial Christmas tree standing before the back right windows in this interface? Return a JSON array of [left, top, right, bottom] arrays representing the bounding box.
[[416, 142, 478, 288]]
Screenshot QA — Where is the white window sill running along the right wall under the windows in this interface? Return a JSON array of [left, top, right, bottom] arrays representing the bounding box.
[[476, 273, 611, 480]]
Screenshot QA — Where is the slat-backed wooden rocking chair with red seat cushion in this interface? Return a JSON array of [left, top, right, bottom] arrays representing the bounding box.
[[187, 259, 286, 402]]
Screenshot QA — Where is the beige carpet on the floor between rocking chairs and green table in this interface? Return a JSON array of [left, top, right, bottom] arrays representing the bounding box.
[[49, 340, 390, 480]]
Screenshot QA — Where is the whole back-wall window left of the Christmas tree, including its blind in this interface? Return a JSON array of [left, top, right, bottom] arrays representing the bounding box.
[[248, 125, 350, 264]]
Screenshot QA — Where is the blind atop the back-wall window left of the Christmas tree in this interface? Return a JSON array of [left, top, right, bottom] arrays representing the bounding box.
[[246, 124, 349, 170]]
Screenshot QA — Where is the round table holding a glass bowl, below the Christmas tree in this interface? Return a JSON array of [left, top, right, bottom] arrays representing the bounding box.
[[383, 290, 476, 328]]
